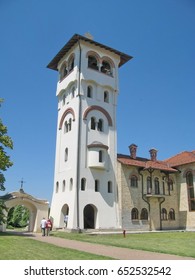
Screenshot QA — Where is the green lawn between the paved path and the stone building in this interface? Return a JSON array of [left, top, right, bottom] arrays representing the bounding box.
[[49, 231, 195, 258]]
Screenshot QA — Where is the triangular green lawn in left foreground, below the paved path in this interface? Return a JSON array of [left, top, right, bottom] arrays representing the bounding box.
[[0, 233, 112, 260]]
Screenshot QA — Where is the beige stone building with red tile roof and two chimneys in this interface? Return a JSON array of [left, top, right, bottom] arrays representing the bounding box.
[[117, 144, 195, 230]]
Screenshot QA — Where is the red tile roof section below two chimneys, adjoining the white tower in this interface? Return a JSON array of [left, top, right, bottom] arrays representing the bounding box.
[[117, 154, 177, 172]]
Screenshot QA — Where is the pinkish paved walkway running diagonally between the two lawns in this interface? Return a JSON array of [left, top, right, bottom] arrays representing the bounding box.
[[29, 233, 195, 260]]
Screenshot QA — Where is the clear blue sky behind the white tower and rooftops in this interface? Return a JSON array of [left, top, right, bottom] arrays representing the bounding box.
[[0, 0, 195, 201]]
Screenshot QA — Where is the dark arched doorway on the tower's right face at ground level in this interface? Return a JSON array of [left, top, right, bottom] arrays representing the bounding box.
[[83, 204, 97, 229]]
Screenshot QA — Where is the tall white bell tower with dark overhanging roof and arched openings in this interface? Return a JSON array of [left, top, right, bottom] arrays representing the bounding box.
[[47, 34, 132, 230]]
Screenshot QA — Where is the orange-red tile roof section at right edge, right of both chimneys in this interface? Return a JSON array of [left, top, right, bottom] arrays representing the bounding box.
[[164, 150, 195, 167]]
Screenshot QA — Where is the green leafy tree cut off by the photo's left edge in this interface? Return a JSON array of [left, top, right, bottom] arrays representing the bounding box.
[[0, 98, 13, 225]]
